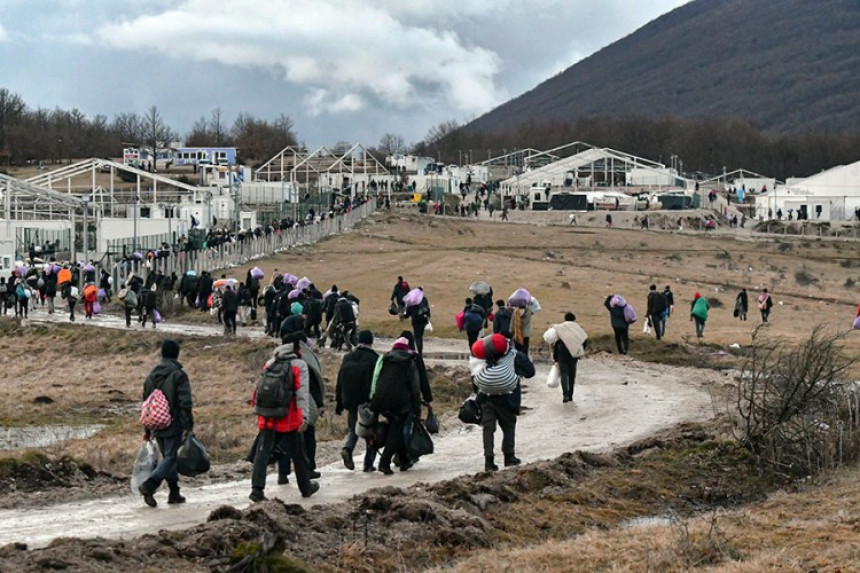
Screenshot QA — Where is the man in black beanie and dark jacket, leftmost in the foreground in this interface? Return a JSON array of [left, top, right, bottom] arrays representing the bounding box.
[[138, 340, 194, 507]]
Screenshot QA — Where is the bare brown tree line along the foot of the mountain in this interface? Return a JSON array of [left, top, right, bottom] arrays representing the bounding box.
[[413, 116, 860, 181]]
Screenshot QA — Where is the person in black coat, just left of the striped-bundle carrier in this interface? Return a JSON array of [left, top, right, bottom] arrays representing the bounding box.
[[370, 337, 421, 475]]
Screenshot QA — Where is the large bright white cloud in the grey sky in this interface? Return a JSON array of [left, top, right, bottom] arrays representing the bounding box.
[[96, 0, 507, 114]]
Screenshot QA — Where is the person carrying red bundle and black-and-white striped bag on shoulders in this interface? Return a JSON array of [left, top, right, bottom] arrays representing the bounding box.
[[472, 334, 535, 472]]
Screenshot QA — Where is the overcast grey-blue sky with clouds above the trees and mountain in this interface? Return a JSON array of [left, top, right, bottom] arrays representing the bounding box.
[[0, 0, 687, 148]]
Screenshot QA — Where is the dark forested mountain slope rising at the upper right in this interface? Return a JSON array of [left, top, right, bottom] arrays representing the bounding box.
[[465, 0, 860, 134]]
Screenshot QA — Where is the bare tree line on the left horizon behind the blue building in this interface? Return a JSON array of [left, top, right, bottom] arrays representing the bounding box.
[[0, 88, 297, 166]]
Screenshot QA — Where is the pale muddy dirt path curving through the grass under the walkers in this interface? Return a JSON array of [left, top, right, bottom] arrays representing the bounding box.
[[0, 313, 721, 547]]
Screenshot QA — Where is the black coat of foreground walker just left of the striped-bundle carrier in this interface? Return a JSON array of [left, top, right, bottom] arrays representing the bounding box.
[[370, 350, 421, 415]]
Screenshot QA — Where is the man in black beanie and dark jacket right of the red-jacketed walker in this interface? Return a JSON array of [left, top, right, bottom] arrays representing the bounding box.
[[334, 330, 379, 472]]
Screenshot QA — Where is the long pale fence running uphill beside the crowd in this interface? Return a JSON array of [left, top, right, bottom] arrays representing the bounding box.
[[111, 201, 376, 290]]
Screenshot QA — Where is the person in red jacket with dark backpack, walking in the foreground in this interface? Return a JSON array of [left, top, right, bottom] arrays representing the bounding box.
[[249, 333, 319, 502]]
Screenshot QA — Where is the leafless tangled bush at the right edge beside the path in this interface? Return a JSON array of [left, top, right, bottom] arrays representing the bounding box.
[[734, 326, 860, 478]]
